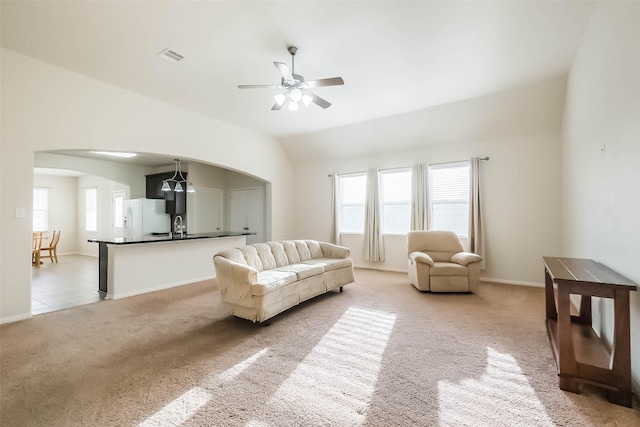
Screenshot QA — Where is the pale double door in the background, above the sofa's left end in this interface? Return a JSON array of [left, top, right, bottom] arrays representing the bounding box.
[[230, 187, 265, 244]]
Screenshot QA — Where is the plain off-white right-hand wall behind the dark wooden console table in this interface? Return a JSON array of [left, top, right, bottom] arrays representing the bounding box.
[[562, 2, 640, 393]]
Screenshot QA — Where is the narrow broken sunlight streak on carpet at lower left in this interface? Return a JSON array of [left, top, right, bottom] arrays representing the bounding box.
[[138, 347, 269, 427]]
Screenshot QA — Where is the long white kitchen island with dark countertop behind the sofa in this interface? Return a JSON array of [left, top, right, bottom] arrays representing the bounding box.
[[89, 231, 255, 299]]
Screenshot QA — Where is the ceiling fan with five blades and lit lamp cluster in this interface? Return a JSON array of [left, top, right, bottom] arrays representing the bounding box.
[[238, 46, 344, 111]]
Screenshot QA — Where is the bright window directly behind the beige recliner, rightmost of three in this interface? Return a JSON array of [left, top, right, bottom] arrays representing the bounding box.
[[429, 162, 469, 237]]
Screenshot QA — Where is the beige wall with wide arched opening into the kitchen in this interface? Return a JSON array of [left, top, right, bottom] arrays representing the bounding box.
[[0, 49, 293, 322]]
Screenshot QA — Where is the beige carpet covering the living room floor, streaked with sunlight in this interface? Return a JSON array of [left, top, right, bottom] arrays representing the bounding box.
[[0, 270, 640, 427]]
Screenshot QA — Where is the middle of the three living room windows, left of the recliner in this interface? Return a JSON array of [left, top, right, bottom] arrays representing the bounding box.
[[380, 168, 411, 234]]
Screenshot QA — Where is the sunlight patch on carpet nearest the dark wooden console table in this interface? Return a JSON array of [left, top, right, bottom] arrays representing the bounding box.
[[438, 347, 555, 427]]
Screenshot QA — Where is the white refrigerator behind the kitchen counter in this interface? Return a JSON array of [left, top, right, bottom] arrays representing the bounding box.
[[124, 199, 171, 239]]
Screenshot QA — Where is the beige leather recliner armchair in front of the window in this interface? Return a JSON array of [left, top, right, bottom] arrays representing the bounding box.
[[407, 231, 482, 292]]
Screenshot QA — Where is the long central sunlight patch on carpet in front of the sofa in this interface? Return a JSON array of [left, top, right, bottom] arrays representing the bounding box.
[[256, 307, 396, 425]]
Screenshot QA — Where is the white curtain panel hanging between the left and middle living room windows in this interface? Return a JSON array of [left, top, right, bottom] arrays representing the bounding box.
[[364, 169, 384, 262]]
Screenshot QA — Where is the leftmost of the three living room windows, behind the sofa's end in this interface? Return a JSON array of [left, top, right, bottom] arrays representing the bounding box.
[[338, 173, 367, 233]]
